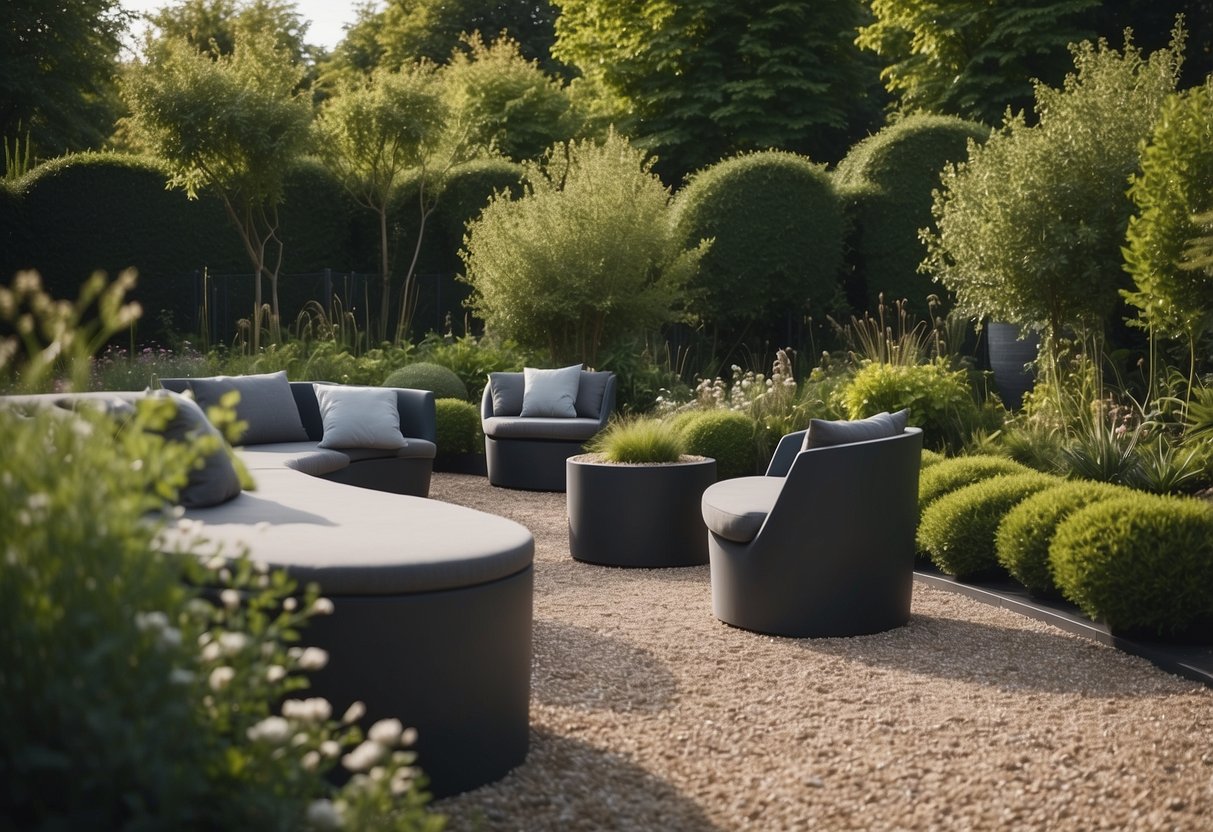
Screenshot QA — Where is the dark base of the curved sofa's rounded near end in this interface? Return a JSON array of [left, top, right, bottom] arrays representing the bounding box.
[[302, 566, 534, 797]]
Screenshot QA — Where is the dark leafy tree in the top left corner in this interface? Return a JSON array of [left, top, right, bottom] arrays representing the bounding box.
[[0, 0, 131, 164]]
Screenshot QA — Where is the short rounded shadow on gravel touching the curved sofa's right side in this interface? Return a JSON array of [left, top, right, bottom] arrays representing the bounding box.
[[531, 620, 678, 713]]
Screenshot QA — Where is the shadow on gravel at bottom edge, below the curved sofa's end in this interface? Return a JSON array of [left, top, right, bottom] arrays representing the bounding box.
[[434, 730, 724, 832]]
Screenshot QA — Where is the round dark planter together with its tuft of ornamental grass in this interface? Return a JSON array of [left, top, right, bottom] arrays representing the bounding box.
[[565, 418, 716, 568]]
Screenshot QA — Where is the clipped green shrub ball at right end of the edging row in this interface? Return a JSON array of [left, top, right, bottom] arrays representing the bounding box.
[[1049, 495, 1213, 634]]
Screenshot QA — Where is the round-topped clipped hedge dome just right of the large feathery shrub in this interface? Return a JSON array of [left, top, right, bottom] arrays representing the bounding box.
[[674, 150, 842, 334]]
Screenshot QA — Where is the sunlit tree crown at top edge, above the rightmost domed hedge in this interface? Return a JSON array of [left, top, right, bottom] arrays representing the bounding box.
[[856, 0, 1099, 124]]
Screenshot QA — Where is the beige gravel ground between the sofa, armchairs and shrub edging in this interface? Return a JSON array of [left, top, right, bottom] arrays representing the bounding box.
[[421, 474, 1213, 832]]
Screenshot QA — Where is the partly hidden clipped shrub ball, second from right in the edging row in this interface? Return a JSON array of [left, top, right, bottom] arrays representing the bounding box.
[[995, 480, 1127, 595]]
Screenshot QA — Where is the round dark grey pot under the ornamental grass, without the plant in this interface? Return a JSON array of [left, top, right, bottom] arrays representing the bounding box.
[[565, 454, 716, 568]]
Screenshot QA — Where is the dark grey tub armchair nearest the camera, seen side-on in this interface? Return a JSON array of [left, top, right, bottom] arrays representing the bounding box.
[[702, 422, 922, 638]]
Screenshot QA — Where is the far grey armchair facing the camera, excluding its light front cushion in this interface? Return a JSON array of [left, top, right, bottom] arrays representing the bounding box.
[[480, 370, 616, 491]]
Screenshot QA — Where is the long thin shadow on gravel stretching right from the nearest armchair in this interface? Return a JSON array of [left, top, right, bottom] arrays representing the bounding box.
[[798, 614, 1178, 696]]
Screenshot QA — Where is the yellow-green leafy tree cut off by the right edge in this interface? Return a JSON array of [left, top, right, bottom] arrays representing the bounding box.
[[1123, 79, 1213, 338]]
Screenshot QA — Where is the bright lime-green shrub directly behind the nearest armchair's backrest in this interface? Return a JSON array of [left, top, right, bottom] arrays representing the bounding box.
[[842, 363, 983, 450]]
